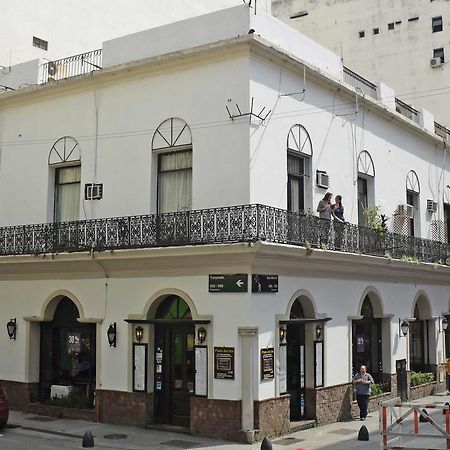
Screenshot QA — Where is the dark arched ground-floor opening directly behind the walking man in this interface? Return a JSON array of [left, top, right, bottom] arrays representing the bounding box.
[[352, 295, 383, 383]]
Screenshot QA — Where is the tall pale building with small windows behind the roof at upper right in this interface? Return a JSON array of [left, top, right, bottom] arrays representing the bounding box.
[[272, 0, 450, 126]]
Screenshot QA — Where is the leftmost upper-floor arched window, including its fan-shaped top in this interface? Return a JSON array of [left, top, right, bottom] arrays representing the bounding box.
[[48, 136, 81, 222]]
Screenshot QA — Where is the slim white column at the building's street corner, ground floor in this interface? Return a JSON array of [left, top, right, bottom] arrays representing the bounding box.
[[238, 327, 258, 431]]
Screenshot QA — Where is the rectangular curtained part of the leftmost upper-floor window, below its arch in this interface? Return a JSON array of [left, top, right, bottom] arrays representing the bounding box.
[[55, 166, 81, 222]]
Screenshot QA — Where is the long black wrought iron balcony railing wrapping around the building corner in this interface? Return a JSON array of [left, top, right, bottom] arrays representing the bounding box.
[[0, 205, 450, 264]]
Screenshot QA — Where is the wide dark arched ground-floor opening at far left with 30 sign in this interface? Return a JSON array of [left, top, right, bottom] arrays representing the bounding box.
[[39, 297, 96, 408]]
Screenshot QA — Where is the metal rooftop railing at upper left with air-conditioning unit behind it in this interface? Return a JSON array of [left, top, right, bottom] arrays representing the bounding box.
[[42, 49, 102, 83]]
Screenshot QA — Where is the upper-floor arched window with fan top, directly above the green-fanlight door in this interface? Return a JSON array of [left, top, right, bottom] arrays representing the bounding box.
[[152, 118, 192, 213]]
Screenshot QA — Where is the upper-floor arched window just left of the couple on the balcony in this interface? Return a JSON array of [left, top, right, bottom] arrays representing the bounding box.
[[287, 124, 313, 212]]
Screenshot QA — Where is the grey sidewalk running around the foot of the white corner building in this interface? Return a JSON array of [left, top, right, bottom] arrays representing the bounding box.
[[7, 395, 449, 450]]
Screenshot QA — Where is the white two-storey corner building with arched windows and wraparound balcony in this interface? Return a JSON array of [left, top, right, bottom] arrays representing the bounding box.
[[0, 5, 450, 441]]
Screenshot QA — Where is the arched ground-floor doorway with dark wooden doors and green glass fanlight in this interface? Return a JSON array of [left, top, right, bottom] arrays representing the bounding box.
[[154, 295, 195, 427]]
